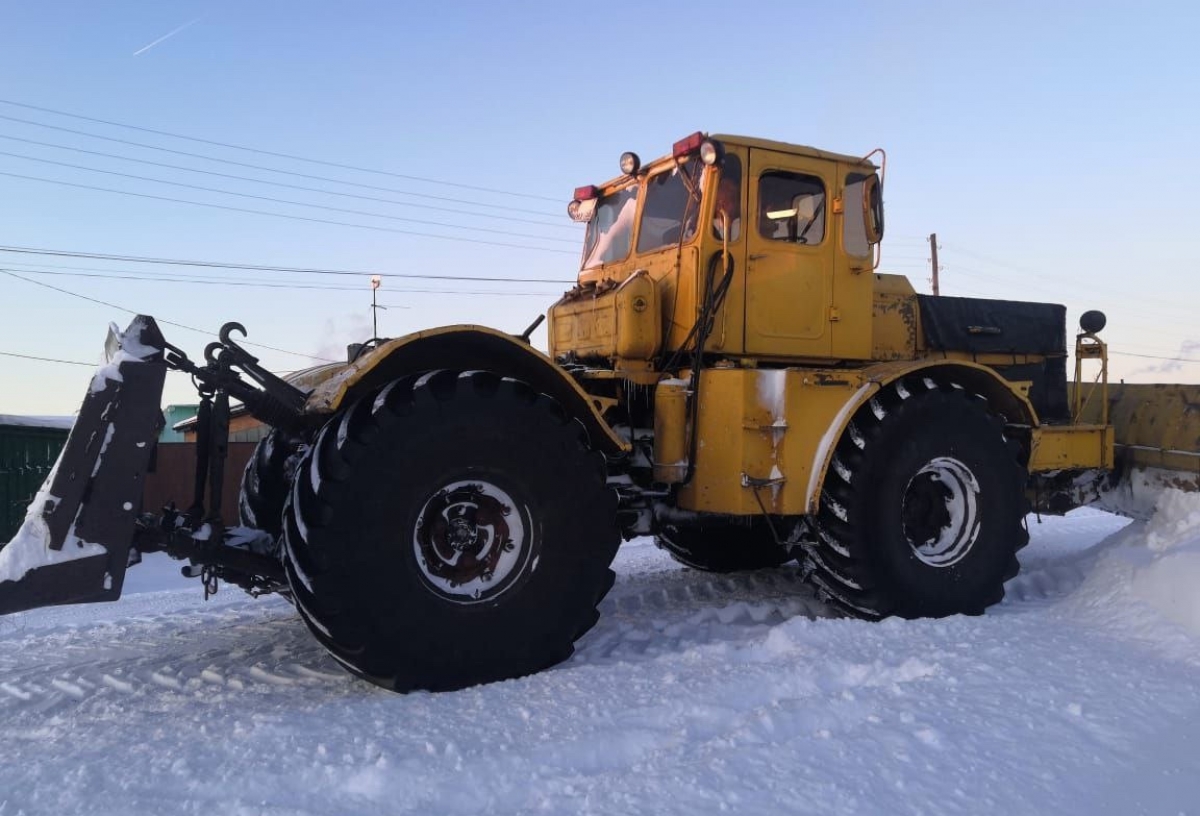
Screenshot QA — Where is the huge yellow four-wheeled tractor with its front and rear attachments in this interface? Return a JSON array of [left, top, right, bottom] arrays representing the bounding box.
[[0, 133, 1200, 691]]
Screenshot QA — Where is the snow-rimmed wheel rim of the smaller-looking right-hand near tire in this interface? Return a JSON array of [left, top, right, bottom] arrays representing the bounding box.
[[900, 456, 980, 566]]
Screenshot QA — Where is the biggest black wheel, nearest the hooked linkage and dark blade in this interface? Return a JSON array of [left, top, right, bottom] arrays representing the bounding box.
[[283, 371, 620, 691]]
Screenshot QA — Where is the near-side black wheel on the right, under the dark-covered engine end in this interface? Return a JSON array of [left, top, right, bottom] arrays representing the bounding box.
[[800, 379, 1028, 619]]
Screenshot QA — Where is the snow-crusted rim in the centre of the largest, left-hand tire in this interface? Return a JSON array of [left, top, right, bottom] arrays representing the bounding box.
[[413, 479, 534, 604]]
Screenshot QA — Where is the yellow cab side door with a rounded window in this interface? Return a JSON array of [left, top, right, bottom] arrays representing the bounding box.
[[745, 149, 836, 358]]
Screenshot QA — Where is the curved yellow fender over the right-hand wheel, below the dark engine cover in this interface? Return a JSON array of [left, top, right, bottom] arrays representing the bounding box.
[[805, 360, 1039, 515]]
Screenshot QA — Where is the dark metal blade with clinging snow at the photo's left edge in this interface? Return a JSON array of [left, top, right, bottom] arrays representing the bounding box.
[[0, 316, 167, 614]]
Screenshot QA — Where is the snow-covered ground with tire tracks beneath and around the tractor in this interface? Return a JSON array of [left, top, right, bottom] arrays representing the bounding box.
[[0, 504, 1200, 816]]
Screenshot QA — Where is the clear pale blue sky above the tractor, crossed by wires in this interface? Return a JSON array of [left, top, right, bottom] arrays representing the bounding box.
[[0, 0, 1200, 414]]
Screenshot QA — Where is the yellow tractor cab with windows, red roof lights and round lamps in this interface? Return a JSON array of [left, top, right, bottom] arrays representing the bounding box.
[[551, 132, 883, 371]]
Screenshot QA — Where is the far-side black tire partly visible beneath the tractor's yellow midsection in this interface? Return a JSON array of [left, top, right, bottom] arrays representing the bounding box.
[[654, 518, 792, 572]]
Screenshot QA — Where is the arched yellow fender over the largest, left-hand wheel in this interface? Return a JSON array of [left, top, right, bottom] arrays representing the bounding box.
[[305, 325, 629, 455]]
